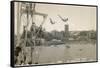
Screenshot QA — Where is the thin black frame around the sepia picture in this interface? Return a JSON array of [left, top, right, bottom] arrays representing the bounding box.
[[10, 1, 98, 67]]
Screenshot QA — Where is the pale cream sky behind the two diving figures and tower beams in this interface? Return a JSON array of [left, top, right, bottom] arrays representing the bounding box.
[[15, 3, 96, 33]]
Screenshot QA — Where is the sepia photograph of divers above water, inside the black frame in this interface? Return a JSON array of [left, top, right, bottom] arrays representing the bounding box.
[[13, 1, 97, 66]]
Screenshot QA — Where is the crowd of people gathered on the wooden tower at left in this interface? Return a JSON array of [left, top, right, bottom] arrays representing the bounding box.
[[14, 22, 43, 65]]
